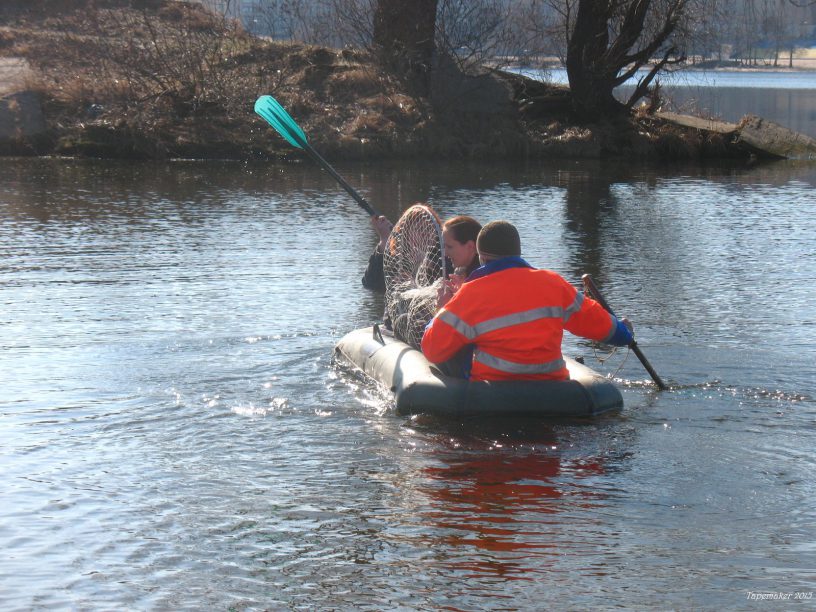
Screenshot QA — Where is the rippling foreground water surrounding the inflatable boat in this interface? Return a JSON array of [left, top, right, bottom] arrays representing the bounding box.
[[0, 159, 816, 610]]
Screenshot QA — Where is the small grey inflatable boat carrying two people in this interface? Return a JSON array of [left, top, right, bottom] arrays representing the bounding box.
[[335, 326, 623, 417]]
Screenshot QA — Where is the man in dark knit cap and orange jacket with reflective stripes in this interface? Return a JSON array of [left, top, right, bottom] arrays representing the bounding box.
[[422, 221, 632, 380]]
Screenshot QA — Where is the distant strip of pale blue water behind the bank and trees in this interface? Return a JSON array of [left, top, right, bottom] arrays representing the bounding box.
[[525, 69, 816, 138]]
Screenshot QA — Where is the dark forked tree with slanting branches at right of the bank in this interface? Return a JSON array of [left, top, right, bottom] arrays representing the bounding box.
[[562, 0, 688, 119]]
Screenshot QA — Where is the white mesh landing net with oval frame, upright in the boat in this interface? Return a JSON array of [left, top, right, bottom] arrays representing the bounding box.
[[383, 204, 445, 348]]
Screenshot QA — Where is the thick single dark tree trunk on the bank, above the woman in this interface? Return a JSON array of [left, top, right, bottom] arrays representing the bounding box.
[[373, 0, 439, 92]]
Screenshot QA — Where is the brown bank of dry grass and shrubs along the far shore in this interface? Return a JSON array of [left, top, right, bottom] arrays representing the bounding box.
[[0, 0, 748, 159]]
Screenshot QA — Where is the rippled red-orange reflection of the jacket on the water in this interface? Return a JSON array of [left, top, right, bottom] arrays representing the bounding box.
[[417, 449, 604, 580]]
